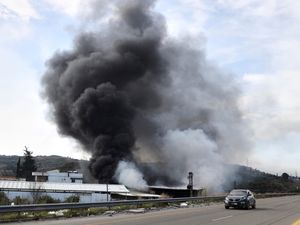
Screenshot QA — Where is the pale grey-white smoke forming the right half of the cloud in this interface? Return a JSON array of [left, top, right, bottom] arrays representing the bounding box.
[[132, 40, 251, 192]]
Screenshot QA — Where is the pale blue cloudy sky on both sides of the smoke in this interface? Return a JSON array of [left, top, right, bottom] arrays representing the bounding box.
[[0, 0, 300, 175]]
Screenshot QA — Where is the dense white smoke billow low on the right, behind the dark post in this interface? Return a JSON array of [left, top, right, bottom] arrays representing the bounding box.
[[158, 129, 224, 191]]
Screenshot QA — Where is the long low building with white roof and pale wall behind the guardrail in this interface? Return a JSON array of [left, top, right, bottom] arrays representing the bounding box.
[[0, 180, 129, 202]]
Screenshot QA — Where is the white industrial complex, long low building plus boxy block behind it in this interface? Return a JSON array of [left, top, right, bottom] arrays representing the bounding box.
[[0, 170, 160, 203]]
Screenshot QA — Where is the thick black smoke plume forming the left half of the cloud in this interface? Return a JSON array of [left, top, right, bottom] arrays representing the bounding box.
[[43, 1, 167, 182]]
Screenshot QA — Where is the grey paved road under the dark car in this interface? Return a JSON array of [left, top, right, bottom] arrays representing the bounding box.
[[3, 196, 300, 225]]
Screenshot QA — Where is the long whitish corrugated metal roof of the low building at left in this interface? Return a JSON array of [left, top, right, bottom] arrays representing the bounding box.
[[0, 180, 129, 193]]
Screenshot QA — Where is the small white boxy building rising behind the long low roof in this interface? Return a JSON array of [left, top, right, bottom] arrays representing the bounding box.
[[32, 170, 83, 183]]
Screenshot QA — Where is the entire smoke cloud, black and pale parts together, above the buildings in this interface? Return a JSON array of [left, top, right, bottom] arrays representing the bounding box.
[[43, 0, 248, 191]]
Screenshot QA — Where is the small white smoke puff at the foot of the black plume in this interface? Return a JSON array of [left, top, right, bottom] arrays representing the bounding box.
[[114, 161, 148, 190]]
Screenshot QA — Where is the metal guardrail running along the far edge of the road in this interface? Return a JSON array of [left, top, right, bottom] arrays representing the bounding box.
[[0, 193, 296, 213]]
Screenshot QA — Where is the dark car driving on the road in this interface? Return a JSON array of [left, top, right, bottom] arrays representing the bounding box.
[[224, 189, 256, 209]]
